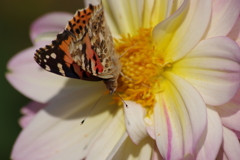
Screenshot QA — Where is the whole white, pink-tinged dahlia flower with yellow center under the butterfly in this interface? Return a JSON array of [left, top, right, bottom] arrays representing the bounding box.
[[6, 0, 240, 160]]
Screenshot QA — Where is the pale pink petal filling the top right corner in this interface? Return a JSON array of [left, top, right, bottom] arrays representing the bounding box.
[[206, 0, 240, 38]]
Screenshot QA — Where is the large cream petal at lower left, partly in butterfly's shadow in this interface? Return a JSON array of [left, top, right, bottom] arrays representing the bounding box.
[[11, 90, 118, 160]]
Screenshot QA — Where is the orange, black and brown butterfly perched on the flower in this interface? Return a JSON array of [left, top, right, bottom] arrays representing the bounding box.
[[34, 3, 121, 94]]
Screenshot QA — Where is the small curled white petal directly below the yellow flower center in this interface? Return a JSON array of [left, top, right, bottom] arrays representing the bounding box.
[[124, 101, 147, 144]]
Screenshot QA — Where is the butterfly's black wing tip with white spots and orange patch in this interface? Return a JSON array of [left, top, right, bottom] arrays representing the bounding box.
[[34, 30, 102, 81]]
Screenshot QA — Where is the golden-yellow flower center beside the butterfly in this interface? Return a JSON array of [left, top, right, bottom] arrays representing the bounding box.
[[115, 29, 171, 110]]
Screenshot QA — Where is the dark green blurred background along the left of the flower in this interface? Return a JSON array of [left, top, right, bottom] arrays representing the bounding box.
[[0, 0, 83, 160]]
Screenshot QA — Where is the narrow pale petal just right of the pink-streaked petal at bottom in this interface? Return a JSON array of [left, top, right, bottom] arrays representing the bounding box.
[[197, 106, 223, 160]]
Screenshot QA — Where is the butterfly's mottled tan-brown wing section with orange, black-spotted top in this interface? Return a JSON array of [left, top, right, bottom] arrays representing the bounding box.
[[66, 4, 120, 79]]
